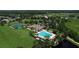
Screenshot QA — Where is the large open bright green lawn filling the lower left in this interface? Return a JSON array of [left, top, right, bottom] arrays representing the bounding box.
[[0, 26, 34, 48]]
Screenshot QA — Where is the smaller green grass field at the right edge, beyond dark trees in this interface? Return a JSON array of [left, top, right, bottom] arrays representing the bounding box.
[[66, 20, 79, 34]]
